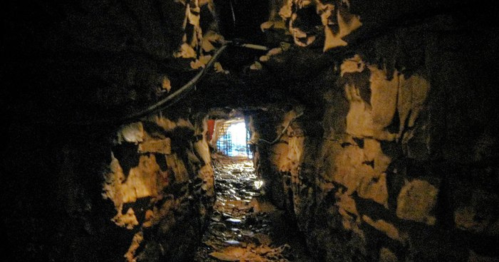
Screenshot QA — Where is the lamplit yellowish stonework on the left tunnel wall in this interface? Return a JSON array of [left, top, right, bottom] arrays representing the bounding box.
[[103, 115, 214, 261]]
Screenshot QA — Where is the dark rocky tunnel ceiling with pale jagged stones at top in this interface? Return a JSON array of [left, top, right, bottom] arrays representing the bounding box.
[[2, 0, 493, 122]]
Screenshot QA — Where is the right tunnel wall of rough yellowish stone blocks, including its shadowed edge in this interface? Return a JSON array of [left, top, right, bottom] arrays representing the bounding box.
[[260, 1, 499, 261]]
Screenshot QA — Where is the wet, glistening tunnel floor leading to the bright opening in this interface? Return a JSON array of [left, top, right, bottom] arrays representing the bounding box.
[[195, 157, 313, 262]]
